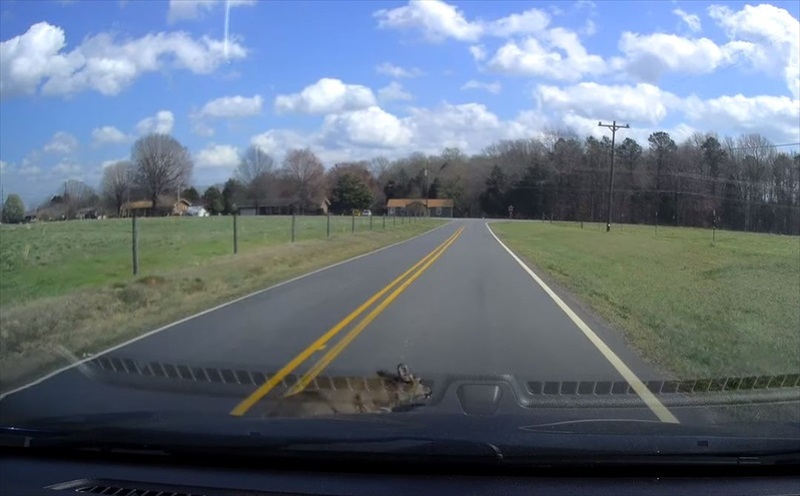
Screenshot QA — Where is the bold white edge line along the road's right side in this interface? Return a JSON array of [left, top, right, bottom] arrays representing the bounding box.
[[486, 222, 680, 424]]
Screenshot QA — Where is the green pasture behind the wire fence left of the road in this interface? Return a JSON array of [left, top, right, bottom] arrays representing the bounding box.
[[0, 216, 405, 307]]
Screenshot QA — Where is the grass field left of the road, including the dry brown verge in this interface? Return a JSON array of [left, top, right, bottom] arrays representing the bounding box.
[[0, 217, 443, 390]]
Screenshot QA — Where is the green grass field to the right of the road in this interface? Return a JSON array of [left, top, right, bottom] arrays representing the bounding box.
[[492, 222, 800, 378]]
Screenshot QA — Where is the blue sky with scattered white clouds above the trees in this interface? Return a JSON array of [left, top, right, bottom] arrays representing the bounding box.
[[0, 0, 800, 206]]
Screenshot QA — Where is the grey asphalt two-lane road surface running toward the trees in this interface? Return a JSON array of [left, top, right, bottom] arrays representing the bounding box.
[[0, 220, 695, 421]]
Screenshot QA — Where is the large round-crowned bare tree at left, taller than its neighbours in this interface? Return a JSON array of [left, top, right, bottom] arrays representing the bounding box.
[[131, 134, 194, 210]]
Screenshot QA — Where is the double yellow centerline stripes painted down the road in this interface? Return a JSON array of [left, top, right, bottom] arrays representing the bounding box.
[[230, 228, 463, 416]]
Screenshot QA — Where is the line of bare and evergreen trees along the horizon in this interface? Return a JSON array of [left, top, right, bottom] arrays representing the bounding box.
[[4, 130, 800, 234]]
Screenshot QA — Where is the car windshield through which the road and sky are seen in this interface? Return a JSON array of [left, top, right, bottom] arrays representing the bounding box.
[[0, 0, 800, 462]]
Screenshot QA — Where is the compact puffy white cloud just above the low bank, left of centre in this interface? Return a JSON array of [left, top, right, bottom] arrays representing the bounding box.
[[275, 78, 376, 114]]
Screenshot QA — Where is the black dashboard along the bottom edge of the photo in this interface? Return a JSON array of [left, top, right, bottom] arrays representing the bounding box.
[[0, 449, 800, 496]]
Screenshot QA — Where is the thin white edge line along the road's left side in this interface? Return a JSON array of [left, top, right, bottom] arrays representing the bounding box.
[[0, 220, 453, 401]]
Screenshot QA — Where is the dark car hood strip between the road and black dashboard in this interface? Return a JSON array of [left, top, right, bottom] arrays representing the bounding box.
[[0, 412, 800, 465]]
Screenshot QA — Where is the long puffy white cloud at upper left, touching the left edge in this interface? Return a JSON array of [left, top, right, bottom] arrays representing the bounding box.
[[0, 22, 247, 98]]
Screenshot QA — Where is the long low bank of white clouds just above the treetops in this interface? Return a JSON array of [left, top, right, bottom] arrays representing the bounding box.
[[244, 88, 800, 163]]
